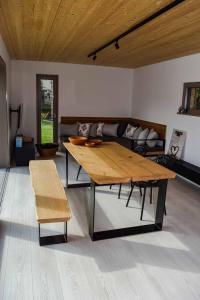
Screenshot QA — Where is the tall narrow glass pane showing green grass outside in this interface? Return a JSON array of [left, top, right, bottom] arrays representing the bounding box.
[[41, 79, 54, 144]]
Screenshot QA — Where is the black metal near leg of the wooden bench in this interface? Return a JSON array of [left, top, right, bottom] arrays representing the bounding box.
[[38, 222, 67, 246]]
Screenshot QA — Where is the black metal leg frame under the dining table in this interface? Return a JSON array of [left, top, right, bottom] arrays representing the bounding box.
[[66, 149, 168, 241]]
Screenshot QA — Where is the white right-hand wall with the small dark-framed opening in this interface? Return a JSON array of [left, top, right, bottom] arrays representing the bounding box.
[[132, 54, 200, 166]]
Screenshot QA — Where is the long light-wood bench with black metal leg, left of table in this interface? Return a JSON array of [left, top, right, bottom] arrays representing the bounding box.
[[29, 160, 71, 246]]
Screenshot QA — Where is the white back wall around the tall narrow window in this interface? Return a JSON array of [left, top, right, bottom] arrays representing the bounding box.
[[11, 60, 133, 141]]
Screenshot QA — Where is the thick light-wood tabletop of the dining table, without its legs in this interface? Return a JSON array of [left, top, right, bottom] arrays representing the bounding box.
[[64, 142, 176, 184]]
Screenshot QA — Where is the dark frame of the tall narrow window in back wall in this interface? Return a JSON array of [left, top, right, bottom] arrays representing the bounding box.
[[36, 74, 58, 143]]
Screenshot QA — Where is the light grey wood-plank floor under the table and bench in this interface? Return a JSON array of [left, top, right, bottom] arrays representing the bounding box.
[[0, 157, 200, 300]]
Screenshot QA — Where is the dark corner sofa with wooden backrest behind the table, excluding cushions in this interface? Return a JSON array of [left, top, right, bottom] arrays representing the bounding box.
[[59, 116, 166, 156]]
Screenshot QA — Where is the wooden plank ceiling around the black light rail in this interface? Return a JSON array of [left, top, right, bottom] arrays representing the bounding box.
[[0, 0, 200, 68]]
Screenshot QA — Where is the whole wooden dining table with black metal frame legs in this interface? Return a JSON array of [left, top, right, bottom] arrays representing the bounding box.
[[63, 142, 176, 241]]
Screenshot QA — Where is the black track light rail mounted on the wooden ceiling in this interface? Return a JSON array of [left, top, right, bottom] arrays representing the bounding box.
[[88, 0, 185, 59]]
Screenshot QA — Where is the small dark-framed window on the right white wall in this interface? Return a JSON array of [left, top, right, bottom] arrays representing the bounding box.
[[182, 82, 200, 116]]
